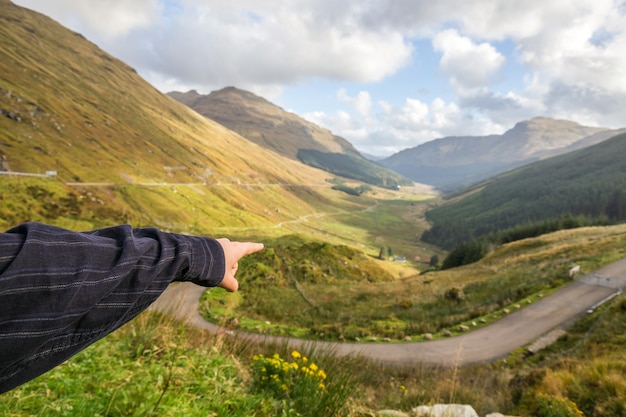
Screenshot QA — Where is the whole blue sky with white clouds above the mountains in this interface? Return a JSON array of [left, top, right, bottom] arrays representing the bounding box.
[[13, 0, 626, 156]]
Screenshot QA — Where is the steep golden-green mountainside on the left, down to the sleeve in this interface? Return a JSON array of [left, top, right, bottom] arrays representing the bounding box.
[[0, 0, 336, 231]]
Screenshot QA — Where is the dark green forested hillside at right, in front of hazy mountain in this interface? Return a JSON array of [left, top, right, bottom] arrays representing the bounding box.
[[422, 134, 626, 249]]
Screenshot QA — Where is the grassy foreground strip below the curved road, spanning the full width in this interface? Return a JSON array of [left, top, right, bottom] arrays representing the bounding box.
[[6, 295, 626, 417]]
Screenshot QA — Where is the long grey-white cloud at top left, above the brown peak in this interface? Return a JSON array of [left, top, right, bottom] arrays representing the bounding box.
[[17, 0, 412, 86]]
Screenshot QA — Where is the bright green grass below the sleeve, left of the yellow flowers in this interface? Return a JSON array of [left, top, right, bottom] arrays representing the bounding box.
[[0, 314, 276, 416]]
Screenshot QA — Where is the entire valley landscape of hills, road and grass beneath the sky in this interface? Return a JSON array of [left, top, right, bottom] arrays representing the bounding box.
[[0, 0, 626, 417]]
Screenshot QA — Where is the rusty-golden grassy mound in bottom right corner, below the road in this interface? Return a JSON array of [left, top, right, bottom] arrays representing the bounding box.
[[504, 295, 626, 417]]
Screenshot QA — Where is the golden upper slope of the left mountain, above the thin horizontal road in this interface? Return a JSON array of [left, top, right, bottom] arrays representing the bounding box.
[[0, 2, 319, 183]]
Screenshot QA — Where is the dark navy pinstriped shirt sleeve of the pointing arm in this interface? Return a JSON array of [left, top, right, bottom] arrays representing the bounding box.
[[0, 223, 224, 393]]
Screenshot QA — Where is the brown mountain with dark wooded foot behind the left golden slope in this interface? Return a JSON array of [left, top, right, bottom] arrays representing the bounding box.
[[168, 87, 412, 188]]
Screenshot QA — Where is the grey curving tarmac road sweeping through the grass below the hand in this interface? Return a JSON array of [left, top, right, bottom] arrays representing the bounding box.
[[150, 259, 626, 367]]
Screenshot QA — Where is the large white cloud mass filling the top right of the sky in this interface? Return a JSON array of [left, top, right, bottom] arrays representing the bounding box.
[[356, 0, 626, 127]]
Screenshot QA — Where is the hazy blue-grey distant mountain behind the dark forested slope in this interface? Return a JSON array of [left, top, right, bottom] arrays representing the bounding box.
[[379, 117, 621, 191]]
